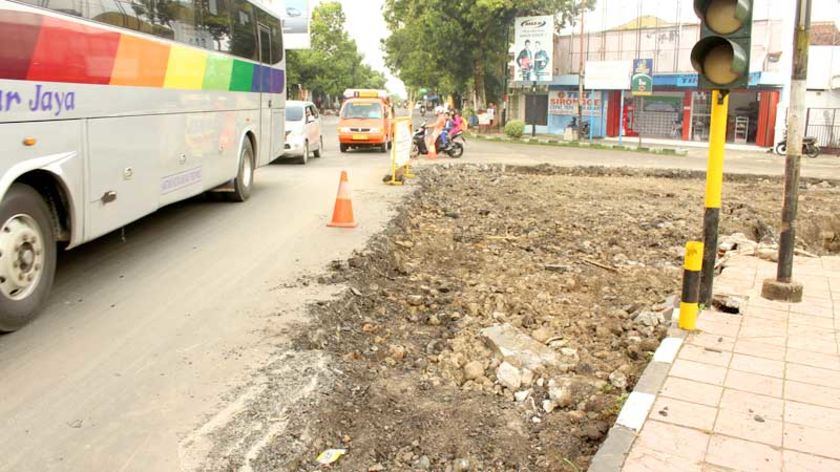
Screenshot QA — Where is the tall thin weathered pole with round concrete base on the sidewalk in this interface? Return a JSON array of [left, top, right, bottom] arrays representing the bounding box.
[[761, 0, 811, 303]]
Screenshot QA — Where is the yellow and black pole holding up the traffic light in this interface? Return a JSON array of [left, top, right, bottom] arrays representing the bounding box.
[[700, 90, 729, 306]]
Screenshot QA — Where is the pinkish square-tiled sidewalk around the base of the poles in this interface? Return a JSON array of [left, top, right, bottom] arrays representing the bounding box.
[[622, 257, 840, 472]]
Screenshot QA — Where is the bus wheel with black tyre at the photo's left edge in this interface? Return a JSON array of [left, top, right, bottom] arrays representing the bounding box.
[[0, 184, 56, 332]]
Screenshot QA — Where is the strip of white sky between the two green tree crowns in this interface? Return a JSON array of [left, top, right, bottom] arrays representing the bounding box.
[[311, 0, 407, 97]]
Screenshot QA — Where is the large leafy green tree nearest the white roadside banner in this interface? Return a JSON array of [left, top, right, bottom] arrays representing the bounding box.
[[382, 0, 594, 106]]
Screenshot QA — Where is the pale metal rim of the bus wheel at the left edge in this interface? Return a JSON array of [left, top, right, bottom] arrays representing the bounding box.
[[0, 215, 44, 300]]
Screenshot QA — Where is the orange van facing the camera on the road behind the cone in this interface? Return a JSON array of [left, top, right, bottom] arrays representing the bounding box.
[[338, 89, 394, 152]]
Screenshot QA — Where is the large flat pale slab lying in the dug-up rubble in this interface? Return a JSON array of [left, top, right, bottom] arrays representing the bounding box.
[[481, 323, 560, 370]]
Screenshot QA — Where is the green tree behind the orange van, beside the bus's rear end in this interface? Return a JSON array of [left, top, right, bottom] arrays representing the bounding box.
[[286, 1, 385, 96]]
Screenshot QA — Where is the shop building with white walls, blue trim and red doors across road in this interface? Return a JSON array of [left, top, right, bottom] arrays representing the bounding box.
[[508, 0, 840, 147]]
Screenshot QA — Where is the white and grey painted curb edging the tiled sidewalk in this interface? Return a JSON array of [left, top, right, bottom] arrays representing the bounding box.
[[588, 306, 687, 472]]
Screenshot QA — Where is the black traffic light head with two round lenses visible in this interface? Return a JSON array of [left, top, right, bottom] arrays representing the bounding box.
[[691, 0, 753, 90]]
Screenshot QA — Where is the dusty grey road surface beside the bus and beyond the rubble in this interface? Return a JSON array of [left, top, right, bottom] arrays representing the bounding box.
[[0, 108, 840, 471]]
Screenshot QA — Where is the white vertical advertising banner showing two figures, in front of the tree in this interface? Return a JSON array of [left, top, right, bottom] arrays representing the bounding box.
[[513, 16, 554, 82]]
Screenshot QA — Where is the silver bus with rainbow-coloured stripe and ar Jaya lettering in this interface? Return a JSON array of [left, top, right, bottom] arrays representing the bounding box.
[[0, 0, 286, 332]]
